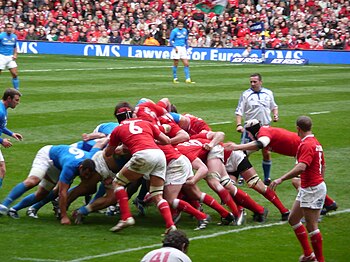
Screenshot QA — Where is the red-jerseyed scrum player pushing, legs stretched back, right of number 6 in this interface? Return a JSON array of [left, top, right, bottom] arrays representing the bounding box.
[[177, 133, 267, 224]]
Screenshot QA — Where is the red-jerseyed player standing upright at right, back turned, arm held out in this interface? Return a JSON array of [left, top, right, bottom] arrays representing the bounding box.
[[270, 116, 327, 262]]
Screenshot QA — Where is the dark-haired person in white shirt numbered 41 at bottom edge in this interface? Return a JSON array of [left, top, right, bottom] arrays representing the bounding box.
[[141, 230, 192, 262]]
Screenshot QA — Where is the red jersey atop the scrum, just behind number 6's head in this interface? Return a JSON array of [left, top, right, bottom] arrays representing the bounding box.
[[135, 102, 167, 125]]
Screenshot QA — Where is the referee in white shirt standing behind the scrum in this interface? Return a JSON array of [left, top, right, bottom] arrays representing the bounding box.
[[235, 73, 278, 185]]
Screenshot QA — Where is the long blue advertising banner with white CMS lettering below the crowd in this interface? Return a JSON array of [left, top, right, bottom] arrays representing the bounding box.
[[17, 41, 350, 64]]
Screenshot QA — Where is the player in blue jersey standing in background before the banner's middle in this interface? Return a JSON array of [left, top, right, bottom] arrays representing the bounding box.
[[169, 19, 195, 84]]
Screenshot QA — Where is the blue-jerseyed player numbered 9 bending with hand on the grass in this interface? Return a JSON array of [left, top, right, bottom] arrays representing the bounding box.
[[0, 140, 106, 224]]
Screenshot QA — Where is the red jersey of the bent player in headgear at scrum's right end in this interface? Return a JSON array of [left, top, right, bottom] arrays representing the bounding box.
[[257, 126, 301, 157]]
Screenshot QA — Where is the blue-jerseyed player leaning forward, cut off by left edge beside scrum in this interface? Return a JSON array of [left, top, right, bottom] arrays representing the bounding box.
[[0, 88, 23, 188]]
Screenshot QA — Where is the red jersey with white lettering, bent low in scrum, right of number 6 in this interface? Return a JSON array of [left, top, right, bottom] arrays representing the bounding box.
[[176, 138, 210, 163]]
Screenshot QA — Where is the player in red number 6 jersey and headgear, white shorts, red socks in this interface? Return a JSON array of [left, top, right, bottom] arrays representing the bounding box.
[[105, 103, 176, 233]]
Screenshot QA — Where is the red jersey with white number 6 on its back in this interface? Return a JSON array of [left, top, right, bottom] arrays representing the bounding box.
[[109, 118, 161, 154]]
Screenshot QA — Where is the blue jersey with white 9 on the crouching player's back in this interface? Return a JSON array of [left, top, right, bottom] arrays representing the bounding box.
[[49, 145, 100, 185]]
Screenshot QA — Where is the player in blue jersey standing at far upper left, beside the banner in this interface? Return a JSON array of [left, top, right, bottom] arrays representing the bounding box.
[[0, 23, 19, 89]]
